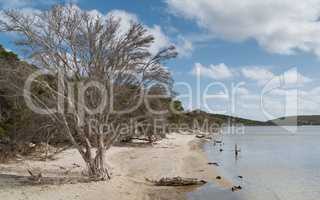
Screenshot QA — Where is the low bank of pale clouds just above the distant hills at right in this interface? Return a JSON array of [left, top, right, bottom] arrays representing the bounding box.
[[192, 63, 320, 120]]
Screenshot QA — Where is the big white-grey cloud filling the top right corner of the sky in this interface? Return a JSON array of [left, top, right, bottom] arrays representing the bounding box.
[[166, 0, 320, 56]]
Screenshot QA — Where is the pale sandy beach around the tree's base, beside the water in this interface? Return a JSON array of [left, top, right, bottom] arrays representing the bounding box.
[[0, 133, 231, 200]]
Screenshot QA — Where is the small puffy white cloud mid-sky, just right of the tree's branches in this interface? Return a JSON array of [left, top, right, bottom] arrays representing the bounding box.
[[192, 63, 233, 80]]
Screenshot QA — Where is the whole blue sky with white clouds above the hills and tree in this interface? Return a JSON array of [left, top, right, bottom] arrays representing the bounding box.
[[0, 0, 320, 120]]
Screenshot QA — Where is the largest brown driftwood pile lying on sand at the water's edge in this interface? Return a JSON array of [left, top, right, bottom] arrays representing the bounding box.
[[146, 176, 207, 186]]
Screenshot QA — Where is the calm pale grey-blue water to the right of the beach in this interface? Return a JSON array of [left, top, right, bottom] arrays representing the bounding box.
[[190, 126, 320, 200]]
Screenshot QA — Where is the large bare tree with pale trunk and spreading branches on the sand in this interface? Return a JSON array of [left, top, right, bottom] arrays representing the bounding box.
[[0, 5, 176, 180]]
